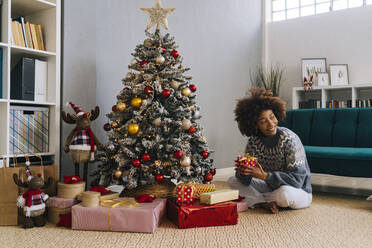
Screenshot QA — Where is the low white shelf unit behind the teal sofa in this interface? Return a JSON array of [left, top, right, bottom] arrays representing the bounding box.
[[292, 83, 372, 109]]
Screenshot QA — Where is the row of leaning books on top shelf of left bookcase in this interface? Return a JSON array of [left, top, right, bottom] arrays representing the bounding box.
[[11, 17, 45, 51]]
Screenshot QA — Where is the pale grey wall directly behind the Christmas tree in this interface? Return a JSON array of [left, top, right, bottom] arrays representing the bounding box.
[[62, 0, 262, 182]]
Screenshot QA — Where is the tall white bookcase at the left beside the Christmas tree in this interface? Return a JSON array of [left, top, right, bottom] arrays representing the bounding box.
[[0, 0, 61, 166]]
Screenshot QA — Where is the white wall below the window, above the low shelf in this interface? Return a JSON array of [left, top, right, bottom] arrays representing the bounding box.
[[267, 6, 372, 107]]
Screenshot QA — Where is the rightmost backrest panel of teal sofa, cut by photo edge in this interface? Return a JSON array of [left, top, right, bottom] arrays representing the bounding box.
[[355, 108, 372, 147]]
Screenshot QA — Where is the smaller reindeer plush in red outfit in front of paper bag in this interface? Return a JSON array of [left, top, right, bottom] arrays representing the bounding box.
[[13, 167, 53, 228]]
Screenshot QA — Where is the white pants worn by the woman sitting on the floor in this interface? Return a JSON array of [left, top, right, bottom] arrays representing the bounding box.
[[227, 176, 313, 209]]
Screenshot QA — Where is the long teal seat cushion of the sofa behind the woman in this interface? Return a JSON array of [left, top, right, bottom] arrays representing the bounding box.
[[304, 146, 372, 160]]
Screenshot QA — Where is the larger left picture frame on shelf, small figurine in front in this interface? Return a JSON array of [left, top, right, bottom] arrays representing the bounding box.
[[301, 58, 327, 82]]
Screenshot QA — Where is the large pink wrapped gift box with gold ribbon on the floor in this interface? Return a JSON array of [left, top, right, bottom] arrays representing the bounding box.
[[72, 198, 167, 233]]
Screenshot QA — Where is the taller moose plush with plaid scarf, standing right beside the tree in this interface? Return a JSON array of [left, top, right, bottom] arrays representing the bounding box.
[[62, 102, 103, 187]]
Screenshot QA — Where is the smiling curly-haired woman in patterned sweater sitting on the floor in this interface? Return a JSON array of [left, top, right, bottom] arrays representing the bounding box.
[[228, 89, 312, 213]]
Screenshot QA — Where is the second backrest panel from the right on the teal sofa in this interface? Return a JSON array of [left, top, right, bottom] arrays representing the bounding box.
[[332, 109, 359, 147]]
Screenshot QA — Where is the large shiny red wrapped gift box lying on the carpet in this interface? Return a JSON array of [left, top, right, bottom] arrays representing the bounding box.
[[167, 199, 238, 229]]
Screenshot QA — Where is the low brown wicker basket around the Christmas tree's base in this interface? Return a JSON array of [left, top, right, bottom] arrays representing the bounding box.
[[120, 179, 176, 198]]
